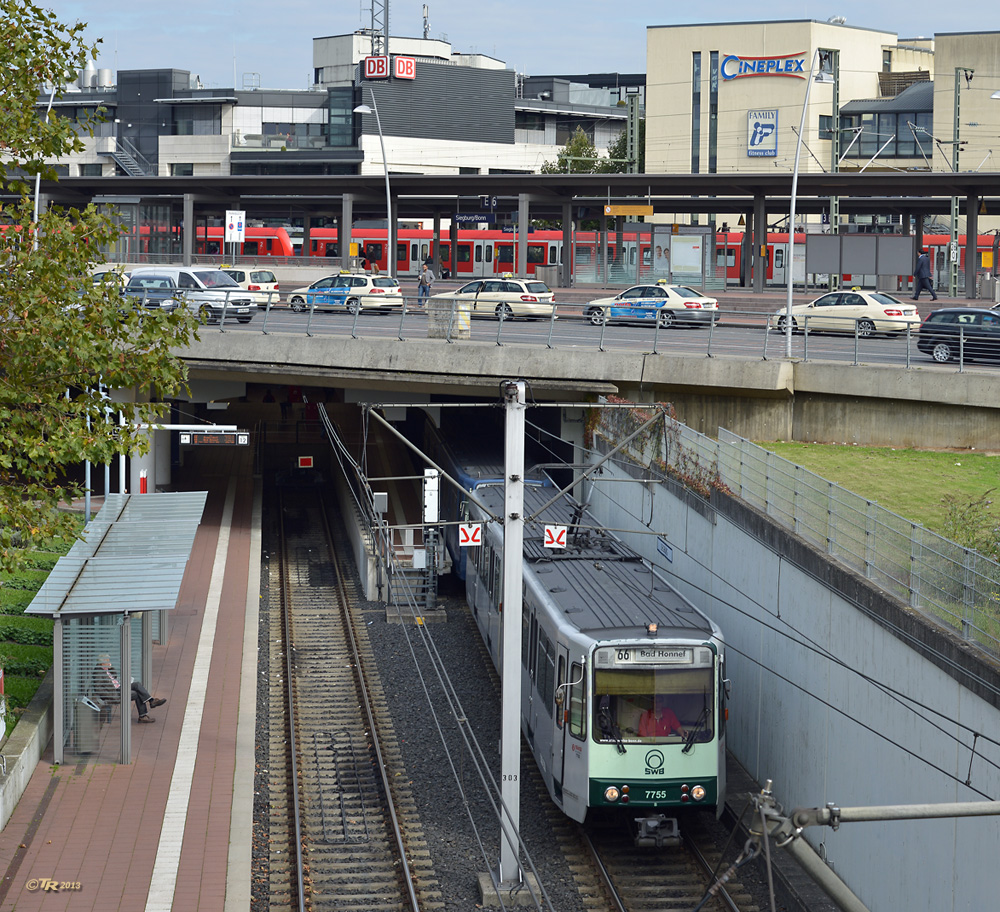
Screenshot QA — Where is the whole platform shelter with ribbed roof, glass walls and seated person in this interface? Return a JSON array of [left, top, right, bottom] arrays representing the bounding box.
[[26, 491, 208, 763]]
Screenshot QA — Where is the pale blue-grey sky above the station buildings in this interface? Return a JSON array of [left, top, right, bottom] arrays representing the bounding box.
[[52, 0, 976, 89]]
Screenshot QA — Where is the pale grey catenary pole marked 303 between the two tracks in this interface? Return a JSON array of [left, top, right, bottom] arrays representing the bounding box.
[[499, 380, 525, 888]]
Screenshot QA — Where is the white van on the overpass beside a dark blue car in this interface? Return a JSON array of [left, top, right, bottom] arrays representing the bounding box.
[[125, 266, 257, 323]]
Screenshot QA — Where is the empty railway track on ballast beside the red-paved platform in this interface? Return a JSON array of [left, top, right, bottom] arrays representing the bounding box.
[[268, 489, 442, 912]]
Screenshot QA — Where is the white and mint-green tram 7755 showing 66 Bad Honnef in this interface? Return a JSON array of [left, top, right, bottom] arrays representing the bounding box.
[[462, 474, 728, 832]]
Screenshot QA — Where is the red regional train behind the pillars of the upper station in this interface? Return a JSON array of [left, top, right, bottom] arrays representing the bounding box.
[[142, 226, 995, 286]]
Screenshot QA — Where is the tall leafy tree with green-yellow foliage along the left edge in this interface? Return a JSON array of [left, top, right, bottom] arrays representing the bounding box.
[[0, 0, 197, 571]]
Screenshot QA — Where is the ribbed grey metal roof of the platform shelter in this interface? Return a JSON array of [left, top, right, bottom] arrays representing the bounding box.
[[25, 491, 208, 618]]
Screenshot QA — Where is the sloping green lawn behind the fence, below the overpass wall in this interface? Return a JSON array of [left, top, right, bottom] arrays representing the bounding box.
[[758, 442, 1000, 535]]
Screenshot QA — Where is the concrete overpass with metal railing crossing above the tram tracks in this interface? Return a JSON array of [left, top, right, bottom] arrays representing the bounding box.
[[179, 311, 1000, 451]]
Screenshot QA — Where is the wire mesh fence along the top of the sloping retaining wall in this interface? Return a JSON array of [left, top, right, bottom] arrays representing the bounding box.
[[599, 407, 1000, 657]]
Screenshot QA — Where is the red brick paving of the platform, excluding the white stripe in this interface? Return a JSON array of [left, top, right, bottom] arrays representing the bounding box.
[[0, 448, 257, 912]]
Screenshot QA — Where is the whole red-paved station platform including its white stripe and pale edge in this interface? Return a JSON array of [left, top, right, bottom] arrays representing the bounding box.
[[0, 447, 261, 912]]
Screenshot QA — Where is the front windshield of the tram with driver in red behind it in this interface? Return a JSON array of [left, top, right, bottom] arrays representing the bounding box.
[[593, 668, 715, 743]]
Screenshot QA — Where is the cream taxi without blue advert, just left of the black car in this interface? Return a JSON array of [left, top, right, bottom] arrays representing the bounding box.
[[768, 288, 920, 336]]
